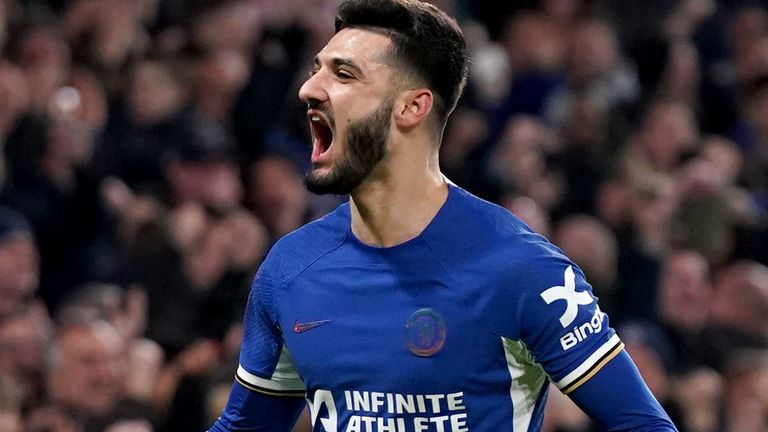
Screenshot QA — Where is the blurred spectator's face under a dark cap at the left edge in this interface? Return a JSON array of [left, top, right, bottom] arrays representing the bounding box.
[[0, 233, 39, 318]]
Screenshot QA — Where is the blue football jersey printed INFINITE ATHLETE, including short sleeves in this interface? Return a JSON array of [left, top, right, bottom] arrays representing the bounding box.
[[237, 185, 623, 432]]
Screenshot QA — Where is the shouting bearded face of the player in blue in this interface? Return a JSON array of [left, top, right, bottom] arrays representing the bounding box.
[[299, 28, 400, 194]]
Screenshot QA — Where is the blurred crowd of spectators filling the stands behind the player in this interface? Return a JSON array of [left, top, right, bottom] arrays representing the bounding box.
[[0, 0, 768, 432]]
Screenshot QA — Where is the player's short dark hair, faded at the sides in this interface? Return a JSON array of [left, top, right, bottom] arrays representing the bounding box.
[[336, 0, 469, 124]]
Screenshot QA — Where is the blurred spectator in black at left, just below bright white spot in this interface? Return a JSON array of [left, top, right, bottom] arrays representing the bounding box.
[[0, 111, 106, 309]]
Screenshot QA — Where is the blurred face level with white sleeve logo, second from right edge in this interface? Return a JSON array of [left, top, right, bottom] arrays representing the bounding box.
[[659, 251, 712, 330]]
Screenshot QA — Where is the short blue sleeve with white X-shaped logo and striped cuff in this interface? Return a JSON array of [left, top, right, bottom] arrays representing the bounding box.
[[515, 252, 624, 394]]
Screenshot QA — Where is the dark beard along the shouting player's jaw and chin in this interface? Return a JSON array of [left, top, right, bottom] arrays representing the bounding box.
[[304, 100, 394, 195]]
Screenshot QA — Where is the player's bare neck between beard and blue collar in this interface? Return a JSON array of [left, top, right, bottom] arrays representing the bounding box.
[[350, 165, 448, 247]]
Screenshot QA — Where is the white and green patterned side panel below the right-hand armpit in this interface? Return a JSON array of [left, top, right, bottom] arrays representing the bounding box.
[[501, 337, 548, 431]]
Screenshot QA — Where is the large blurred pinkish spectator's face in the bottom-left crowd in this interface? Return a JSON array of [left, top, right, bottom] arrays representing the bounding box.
[[48, 322, 125, 414]]
